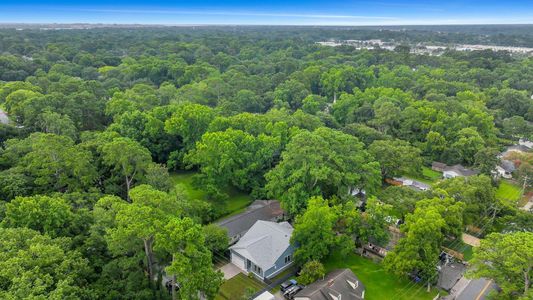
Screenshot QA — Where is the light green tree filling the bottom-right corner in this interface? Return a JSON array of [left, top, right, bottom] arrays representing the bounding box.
[[468, 232, 533, 300]]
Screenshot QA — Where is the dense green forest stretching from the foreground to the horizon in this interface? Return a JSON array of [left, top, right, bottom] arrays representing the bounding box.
[[0, 27, 533, 299]]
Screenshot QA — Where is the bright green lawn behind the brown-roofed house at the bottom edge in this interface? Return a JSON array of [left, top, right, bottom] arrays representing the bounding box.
[[324, 253, 437, 300]]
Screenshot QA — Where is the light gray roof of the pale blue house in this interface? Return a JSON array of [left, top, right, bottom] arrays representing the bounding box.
[[230, 221, 293, 270]]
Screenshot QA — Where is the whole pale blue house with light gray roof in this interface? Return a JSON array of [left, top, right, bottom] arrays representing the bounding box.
[[229, 221, 295, 280]]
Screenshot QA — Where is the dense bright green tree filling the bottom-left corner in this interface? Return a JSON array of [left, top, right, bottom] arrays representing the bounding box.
[[0, 228, 92, 299]]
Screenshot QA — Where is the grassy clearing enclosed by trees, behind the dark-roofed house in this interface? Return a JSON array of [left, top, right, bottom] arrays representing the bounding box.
[[170, 171, 252, 217]]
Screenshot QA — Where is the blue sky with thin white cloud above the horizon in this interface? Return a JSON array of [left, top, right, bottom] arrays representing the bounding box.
[[0, 0, 533, 26]]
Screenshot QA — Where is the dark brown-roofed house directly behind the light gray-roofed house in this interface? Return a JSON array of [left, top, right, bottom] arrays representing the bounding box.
[[217, 200, 283, 245]]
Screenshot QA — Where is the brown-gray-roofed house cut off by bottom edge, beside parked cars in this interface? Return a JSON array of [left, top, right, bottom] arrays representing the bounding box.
[[294, 269, 365, 300]]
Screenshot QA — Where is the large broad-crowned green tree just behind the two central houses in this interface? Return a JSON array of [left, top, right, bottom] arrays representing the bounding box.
[[265, 128, 381, 215]]
